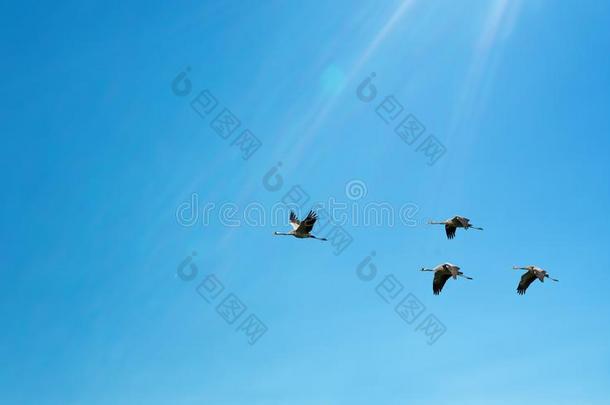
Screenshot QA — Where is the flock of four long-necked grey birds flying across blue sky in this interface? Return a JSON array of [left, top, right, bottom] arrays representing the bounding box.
[[274, 211, 559, 295]]
